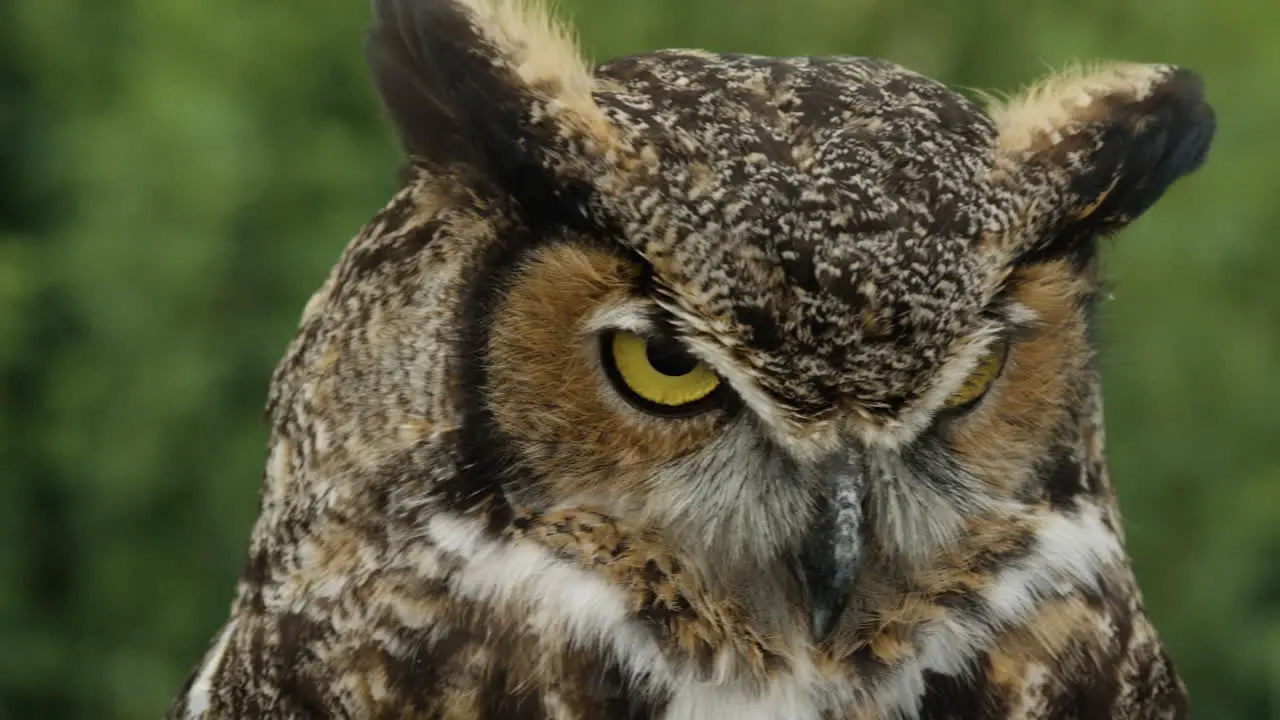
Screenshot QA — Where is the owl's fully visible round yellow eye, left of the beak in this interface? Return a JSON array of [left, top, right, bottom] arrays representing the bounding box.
[[602, 331, 721, 415]]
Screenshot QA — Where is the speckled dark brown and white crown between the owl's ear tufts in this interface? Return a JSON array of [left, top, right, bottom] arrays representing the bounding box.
[[586, 53, 1010, 411]]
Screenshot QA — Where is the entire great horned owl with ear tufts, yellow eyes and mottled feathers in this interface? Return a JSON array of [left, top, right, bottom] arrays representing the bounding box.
[[170, 0, 1215, 720]]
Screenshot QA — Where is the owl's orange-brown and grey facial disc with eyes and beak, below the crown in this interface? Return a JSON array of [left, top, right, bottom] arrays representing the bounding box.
[[479, 189, 1096, 625]]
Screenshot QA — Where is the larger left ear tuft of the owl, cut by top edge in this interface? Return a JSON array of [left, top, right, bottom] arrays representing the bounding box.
[[366, 0, 614, 208]]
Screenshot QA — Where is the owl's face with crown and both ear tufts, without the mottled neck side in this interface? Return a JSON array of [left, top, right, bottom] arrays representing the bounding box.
[[358, 3, 1213, 645]]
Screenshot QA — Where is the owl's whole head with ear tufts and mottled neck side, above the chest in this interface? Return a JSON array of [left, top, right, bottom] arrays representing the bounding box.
[[242, 0, 1215, 681]]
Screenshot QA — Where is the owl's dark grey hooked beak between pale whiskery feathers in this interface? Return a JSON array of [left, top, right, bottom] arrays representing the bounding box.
[[800, 469, 863, 642]]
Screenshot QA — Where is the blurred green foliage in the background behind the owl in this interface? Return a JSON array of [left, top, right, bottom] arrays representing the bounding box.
[[0, 0, 1280, 720]]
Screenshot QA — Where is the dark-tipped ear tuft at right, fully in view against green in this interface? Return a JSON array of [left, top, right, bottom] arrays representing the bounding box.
[[992, 64, 1217, 255]]
